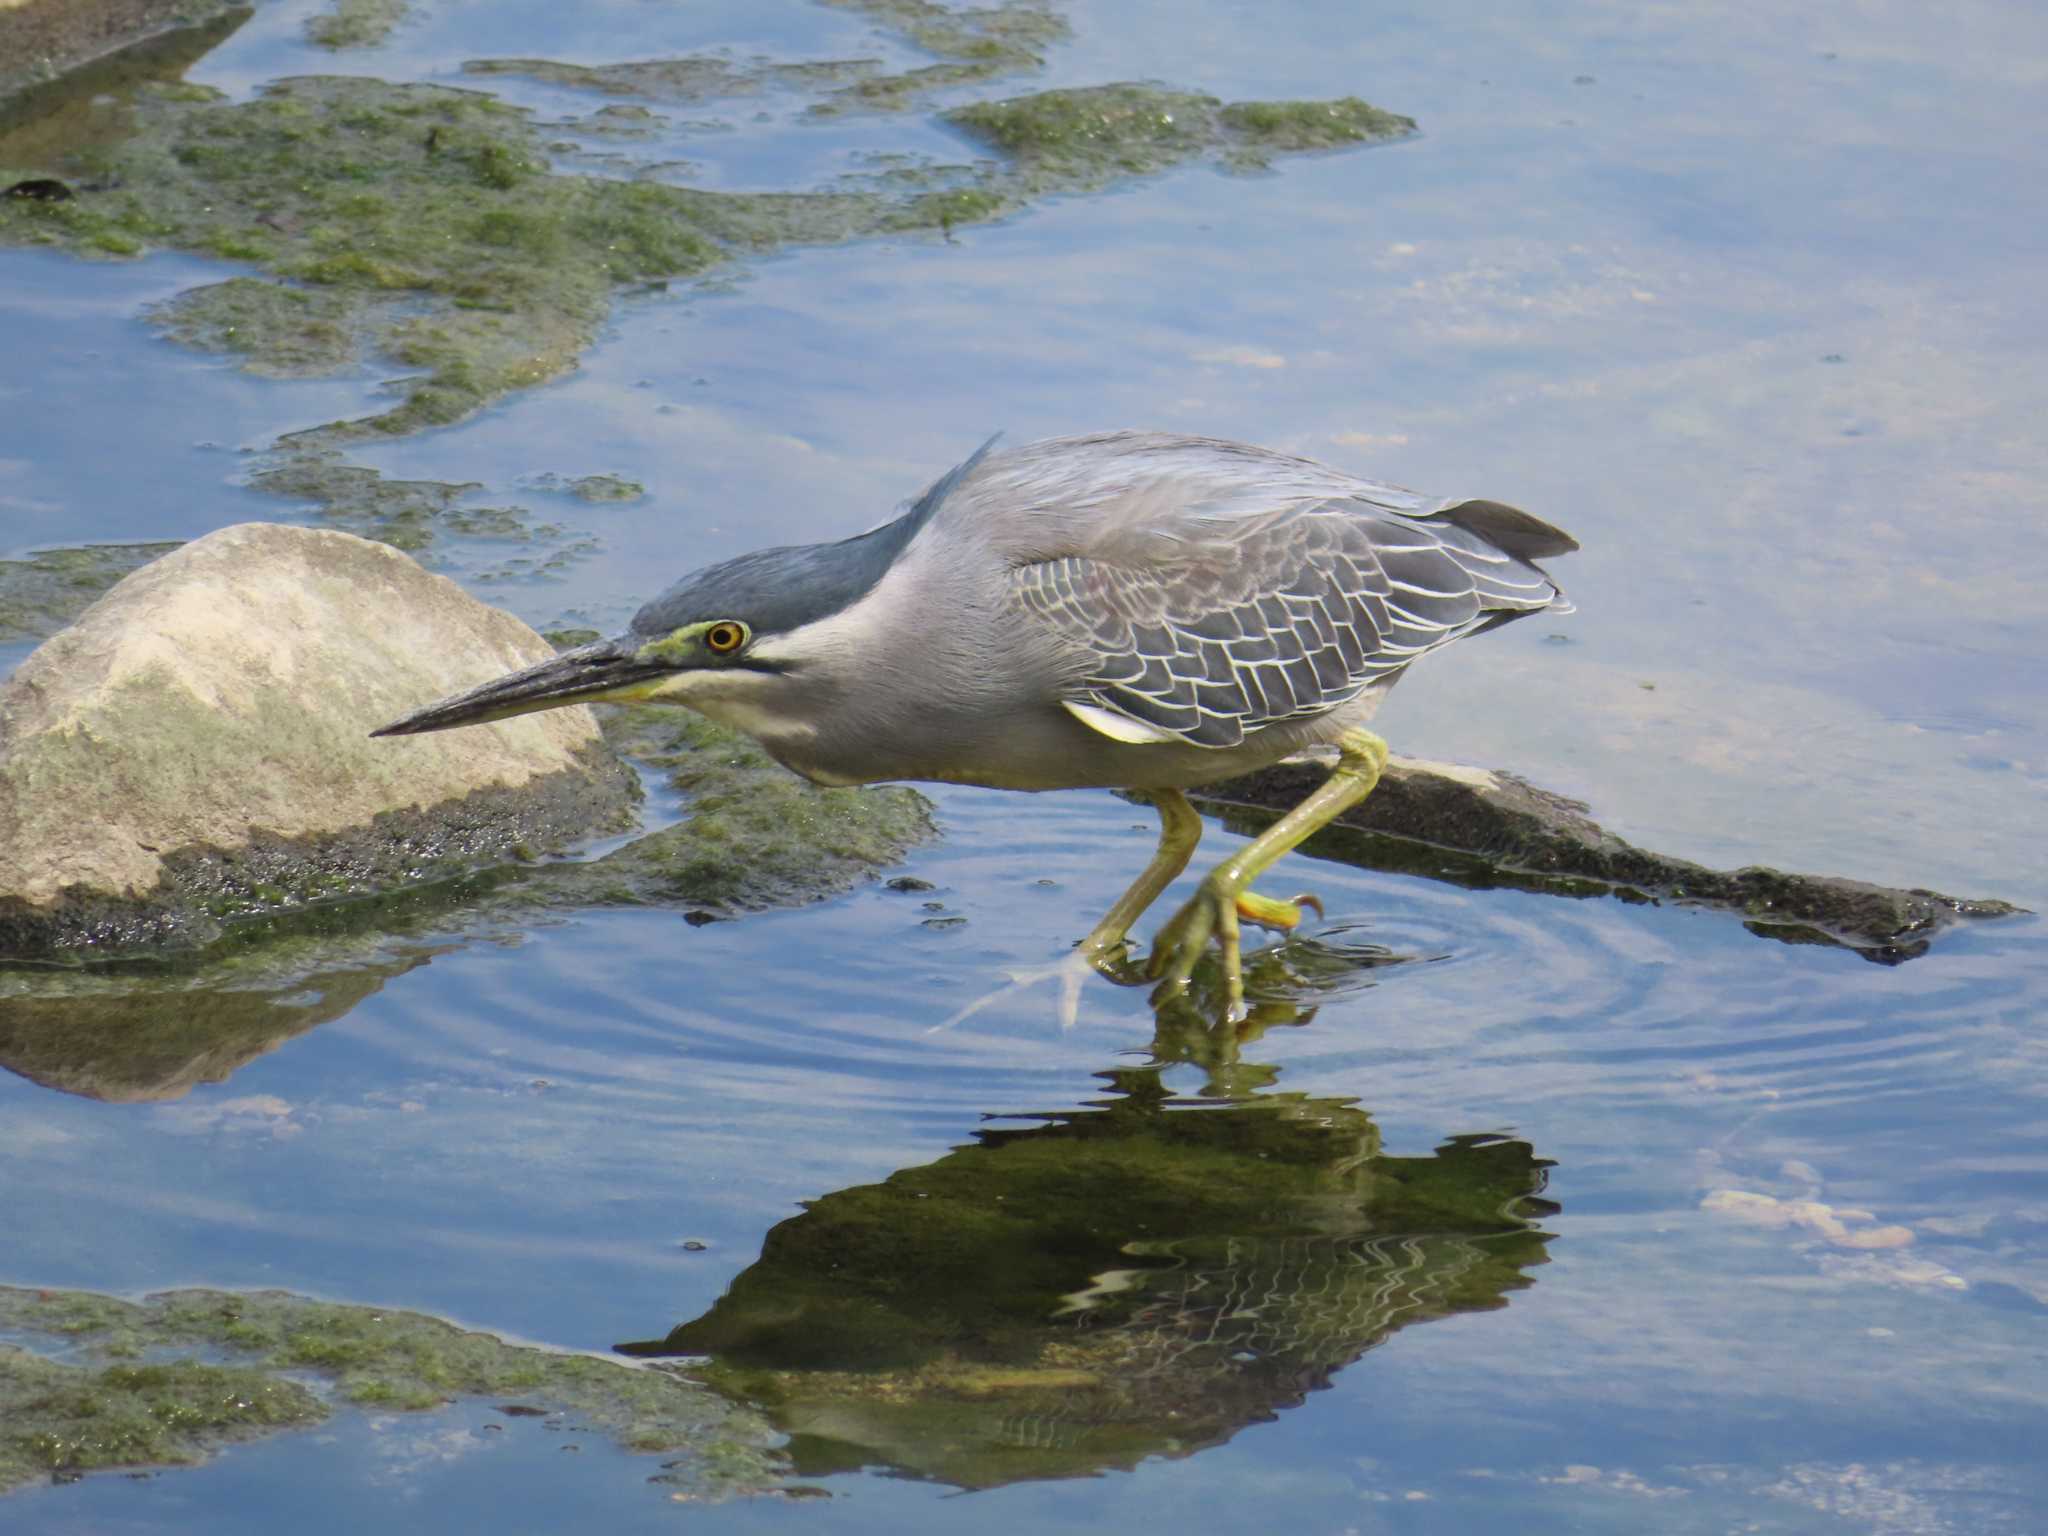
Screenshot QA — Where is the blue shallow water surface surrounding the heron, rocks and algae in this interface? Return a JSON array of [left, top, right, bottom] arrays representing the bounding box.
[[0, 4, 2048, 1532]]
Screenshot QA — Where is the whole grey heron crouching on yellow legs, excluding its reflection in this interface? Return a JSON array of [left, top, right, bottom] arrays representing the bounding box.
[[375, 432, 1577, 1012]]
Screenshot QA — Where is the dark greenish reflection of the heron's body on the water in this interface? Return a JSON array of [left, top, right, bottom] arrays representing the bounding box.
[[618, 1024, 1556, 1489]]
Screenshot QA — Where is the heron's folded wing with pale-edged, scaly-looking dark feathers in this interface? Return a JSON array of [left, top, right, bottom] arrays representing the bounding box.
[[1010, 496, 1559, 748]]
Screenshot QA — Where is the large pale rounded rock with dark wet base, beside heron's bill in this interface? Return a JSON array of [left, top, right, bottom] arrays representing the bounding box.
[[0, 522, 637, 958]]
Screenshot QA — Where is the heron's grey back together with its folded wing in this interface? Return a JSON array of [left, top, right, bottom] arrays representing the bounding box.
[[938, 432, 1575, 748]]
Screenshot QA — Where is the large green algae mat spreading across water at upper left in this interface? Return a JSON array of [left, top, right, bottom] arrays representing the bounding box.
[[0, 41, 1407, 449]]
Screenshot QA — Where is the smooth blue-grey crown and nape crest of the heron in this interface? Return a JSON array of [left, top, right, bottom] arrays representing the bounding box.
[[633, 434, 999, 637]]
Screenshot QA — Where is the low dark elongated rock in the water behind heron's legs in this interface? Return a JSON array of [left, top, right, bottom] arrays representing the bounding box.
[[1200, 758, 2019, 965]]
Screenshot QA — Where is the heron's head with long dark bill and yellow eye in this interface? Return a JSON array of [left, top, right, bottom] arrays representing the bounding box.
[[371, 528, 897, 735]]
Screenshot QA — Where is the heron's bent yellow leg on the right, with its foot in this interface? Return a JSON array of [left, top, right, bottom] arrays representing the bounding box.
[[1147, 731, 1386, 1018]]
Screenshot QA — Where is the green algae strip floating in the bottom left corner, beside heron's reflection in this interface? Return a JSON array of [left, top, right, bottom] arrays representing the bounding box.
[[0, 1286, 780, 1497]]
